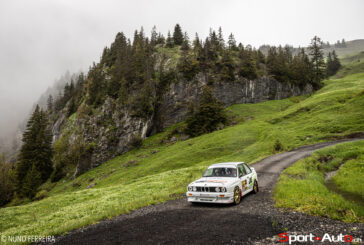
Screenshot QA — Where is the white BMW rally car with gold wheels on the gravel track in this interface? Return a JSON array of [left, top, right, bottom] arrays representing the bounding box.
[[186, 162, 259, 204]]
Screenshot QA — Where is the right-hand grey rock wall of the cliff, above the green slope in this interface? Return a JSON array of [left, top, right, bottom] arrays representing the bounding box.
[[159, 75, 313, 128]]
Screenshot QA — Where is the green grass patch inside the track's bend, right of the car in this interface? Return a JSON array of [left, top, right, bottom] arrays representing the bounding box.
[[274, 140, 364, 222]]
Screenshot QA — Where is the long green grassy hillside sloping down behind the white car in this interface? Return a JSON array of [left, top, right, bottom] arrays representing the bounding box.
[[0, 69, 364, 241]]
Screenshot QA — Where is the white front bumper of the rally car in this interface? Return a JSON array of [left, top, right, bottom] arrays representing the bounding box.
[[186, 191, 234, 203]]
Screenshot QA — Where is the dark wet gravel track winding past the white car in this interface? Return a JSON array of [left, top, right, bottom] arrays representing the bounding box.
[[50, 140, 364, 244]]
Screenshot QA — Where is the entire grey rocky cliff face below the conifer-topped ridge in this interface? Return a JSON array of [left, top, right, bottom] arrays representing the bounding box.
[[52, 74, 312, 175]]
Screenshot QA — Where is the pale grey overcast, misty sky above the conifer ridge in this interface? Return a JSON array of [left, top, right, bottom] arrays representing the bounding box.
[[0, 0, 364, 139]]
